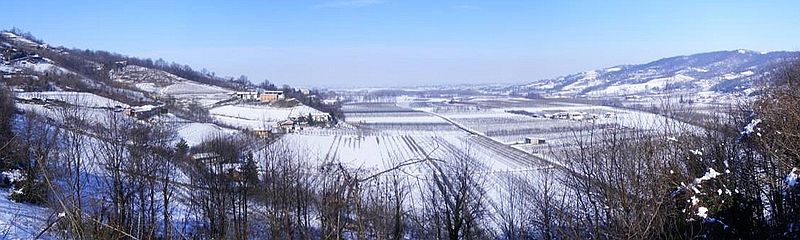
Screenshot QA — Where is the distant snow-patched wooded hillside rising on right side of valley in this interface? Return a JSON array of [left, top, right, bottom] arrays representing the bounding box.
[[503, 49, 800, 96]]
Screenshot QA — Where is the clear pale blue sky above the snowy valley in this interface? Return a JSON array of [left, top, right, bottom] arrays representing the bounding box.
[[0, 0, 800, 87]]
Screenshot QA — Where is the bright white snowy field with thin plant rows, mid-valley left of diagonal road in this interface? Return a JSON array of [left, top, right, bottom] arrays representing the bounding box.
[[279, 128, 531, 172]]
